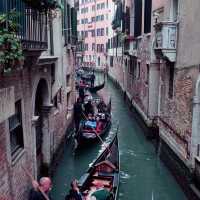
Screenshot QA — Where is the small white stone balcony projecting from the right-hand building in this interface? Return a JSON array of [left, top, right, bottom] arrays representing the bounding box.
[[154, 22, 177, 62]]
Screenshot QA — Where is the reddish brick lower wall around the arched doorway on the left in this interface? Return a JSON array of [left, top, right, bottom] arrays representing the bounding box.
[[0, 59, 72, 200]]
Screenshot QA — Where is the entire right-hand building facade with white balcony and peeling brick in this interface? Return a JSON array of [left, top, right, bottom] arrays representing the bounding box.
[[108, 0, 200, 199]]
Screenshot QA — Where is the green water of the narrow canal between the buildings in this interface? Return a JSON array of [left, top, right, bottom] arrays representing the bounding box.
[[52, 74, 186, 200]]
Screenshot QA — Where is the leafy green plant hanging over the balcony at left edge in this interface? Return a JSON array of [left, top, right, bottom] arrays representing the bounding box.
[[0, 11, 24, 72]]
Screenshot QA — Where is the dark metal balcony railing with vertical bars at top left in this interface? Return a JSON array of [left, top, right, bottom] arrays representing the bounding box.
[[0, 0, 48, 50]]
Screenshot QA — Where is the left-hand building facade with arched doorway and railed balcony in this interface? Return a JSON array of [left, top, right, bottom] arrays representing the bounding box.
[[0, 0, 76, 200]]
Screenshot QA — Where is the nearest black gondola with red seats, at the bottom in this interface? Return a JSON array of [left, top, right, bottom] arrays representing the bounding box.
[[78, 134, 120, 200]]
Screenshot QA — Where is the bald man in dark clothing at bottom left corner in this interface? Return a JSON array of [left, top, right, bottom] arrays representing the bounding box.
[[29, 177, 52, 200]]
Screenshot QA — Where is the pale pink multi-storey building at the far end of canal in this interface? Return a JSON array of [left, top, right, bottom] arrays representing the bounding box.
[[77, 0, 113, 69]]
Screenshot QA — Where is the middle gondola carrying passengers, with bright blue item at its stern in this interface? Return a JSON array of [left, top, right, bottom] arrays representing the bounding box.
[[77, 101, 111, 147]]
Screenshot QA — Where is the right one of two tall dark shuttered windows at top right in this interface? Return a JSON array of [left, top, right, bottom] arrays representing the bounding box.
[[144, 0, 152, 33]]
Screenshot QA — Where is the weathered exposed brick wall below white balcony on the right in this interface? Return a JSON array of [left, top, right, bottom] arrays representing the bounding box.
[[159, 65, 199, 159]]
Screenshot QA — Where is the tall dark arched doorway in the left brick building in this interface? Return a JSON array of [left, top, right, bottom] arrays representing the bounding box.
[[34, 79, 49, 178]]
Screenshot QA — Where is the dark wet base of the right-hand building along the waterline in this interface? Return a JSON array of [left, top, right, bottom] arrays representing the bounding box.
[[105, 72, 200, 200]]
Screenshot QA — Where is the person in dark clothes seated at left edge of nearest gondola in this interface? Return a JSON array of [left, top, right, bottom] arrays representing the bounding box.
[[65, 179, 83, 200]]
